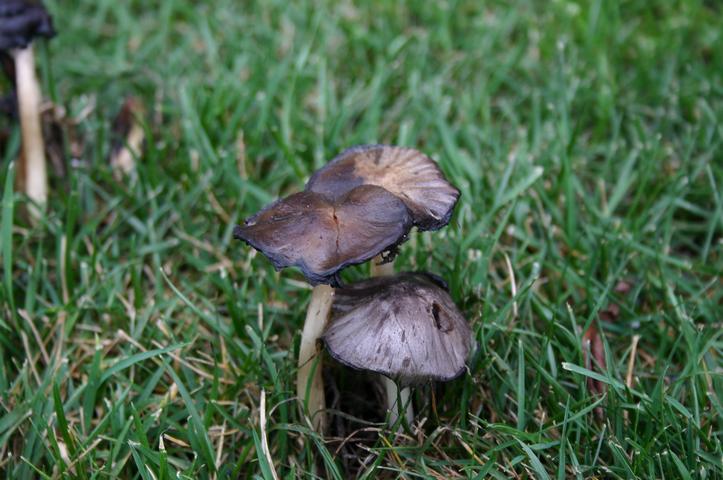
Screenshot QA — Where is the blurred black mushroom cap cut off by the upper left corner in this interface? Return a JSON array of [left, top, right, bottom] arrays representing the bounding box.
[[0, 0, 55, 50]]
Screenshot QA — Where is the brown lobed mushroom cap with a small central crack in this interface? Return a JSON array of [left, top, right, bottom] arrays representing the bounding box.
[[234, 185, 412, 284]]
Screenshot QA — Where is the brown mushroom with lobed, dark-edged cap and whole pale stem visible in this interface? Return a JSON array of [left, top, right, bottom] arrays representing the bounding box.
[[234, 185, 412, 431]]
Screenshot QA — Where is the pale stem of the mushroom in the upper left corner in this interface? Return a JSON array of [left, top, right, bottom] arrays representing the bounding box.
[[13, 45, 48, 219]]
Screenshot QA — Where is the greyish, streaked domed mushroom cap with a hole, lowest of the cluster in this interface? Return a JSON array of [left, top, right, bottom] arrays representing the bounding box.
[[322, 273, 472, 385]]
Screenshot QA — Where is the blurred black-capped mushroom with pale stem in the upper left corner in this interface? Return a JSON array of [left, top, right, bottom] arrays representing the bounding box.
[[0, 0, 55, 218]]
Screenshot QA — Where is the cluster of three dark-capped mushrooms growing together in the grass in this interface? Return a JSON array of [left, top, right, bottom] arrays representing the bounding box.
[[234, 145, 471, 431]]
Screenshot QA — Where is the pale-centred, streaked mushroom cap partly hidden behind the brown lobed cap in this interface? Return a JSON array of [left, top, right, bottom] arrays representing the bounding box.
[[306, 145, 459, 230]]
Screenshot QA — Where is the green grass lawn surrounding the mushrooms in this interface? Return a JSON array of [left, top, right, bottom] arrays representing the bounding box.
[[0, 0, 723, 479]]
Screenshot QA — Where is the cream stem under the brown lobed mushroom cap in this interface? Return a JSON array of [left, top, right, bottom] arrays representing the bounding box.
[[296, 285, 334, 432]]
